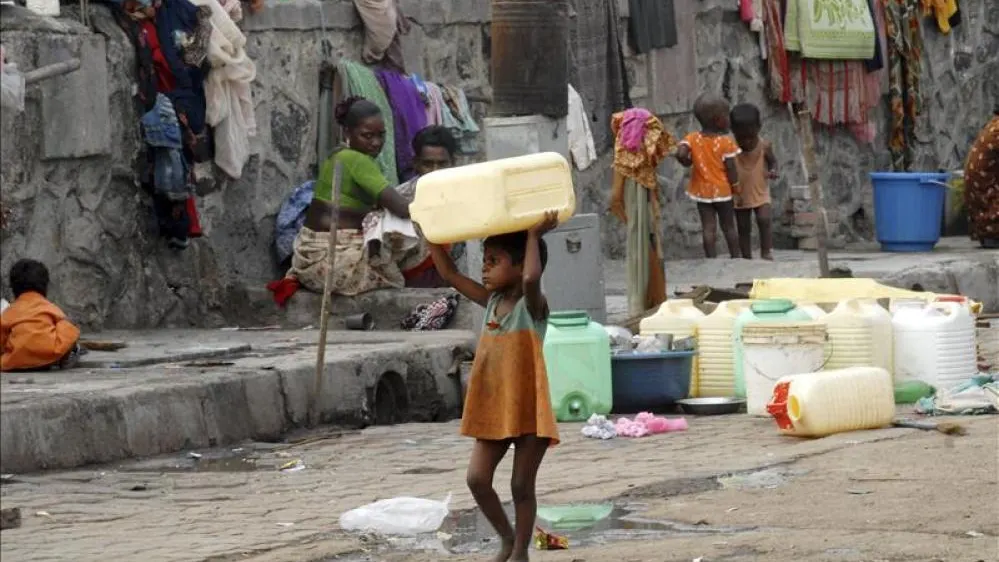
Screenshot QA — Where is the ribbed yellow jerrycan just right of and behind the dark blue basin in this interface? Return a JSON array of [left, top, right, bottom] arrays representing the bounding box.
[[697, 299, 753, 397]]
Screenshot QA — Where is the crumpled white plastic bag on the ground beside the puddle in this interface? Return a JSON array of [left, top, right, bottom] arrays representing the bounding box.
[[340, 494, 451, 535]]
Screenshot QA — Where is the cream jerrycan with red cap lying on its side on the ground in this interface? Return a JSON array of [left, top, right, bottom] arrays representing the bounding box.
[[767, 367, 895, 437]]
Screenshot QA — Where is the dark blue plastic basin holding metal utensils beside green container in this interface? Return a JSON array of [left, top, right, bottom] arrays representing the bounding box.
[[611, 351, 697, 414]]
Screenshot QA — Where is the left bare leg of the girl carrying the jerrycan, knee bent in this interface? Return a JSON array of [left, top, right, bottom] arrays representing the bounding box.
[[466, 439, 514, 562]]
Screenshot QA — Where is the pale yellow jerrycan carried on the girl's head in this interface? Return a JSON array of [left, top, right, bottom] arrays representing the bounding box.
[[409, 152, 576, 244]]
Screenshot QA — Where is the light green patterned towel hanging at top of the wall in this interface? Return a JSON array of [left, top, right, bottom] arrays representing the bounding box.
[[785, 0, 876, 60]]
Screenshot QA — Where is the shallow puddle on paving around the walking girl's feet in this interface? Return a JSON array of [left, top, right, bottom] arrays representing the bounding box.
[[331, 504, 751, 562]]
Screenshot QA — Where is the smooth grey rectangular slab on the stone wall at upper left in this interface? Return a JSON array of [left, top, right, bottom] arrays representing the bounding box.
[[38, 35, 111, 159]]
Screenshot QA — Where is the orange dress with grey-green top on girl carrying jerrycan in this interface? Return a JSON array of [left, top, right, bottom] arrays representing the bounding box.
[[461, 295, 559, 446]]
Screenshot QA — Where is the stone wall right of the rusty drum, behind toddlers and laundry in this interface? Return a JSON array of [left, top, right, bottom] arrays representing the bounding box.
[[581, 0, 999, 258]]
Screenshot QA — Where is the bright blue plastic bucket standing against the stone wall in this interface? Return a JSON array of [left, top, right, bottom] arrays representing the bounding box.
[[871, 172, 950, 252]]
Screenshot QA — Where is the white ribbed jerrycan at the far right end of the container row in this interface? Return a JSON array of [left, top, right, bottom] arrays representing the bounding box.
[[892, 302, 978, 391]]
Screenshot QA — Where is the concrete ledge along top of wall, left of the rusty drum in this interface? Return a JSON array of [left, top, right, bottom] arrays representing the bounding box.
[[243, 0, 491, 31]]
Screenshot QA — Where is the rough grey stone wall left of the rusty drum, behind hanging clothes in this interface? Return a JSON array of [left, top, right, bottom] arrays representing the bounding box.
[[0, 0, 490, 328]]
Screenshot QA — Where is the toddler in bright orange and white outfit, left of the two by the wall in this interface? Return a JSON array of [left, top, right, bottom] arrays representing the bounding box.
[[676, 94, 742, 258]]
